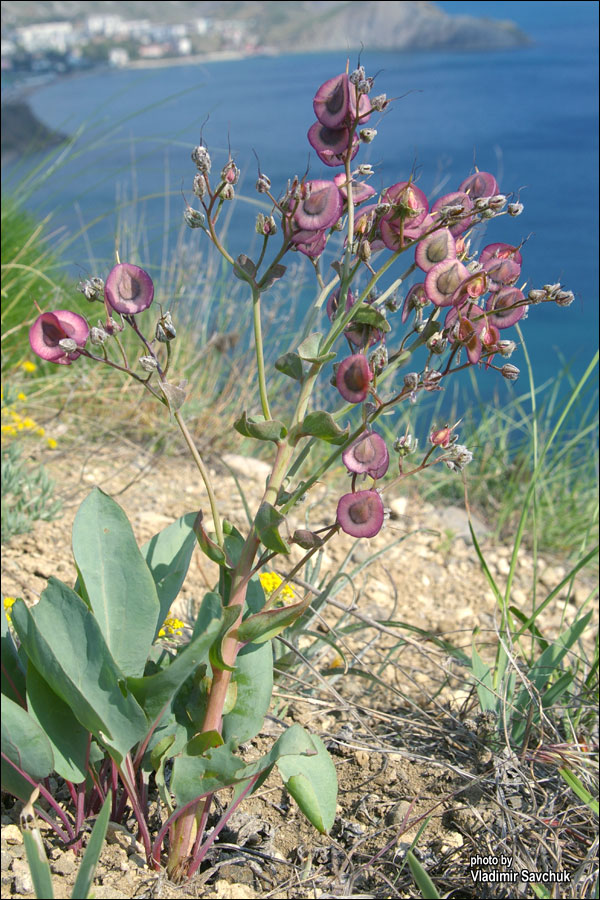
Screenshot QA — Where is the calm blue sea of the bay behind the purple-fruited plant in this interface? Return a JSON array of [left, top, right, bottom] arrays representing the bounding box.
[[3, 0, 599, 395]]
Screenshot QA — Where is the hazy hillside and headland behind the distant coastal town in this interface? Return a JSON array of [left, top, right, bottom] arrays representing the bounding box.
[[2, 0, 528, 52]]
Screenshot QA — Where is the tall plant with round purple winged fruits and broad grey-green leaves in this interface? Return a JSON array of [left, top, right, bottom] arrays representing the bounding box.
[[3, 66, 573, 879]]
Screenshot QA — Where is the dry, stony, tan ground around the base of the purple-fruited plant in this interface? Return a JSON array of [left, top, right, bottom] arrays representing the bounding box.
[[2, 444, 593, 898]]
